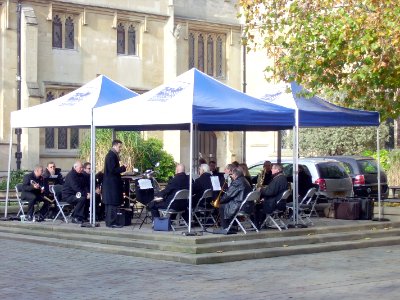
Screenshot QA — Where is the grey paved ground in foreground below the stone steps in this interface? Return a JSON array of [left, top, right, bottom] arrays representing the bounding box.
[[0, 239, 400, 300]]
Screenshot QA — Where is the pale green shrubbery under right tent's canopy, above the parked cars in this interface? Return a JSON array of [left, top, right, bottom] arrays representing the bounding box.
[[284, 124, 389, 157]]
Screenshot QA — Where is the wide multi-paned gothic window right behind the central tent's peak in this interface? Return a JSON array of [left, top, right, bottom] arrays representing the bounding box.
[[188, 31, 226, 78]]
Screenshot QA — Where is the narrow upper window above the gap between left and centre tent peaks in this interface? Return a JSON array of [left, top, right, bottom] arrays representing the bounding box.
[[117, 22, 138, 55]]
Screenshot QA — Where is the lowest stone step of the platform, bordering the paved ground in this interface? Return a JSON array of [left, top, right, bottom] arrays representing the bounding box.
[[0, 232, 400, 265]]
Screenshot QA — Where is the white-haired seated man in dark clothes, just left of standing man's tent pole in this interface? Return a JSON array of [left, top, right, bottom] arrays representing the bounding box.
[[62, 160, 90, 223]]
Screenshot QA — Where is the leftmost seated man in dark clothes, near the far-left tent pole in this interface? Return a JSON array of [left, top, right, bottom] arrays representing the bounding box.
[[21, 165, 49, 222]]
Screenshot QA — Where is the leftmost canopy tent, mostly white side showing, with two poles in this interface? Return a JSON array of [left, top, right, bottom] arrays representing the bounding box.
[[5, 75, 138, 220]]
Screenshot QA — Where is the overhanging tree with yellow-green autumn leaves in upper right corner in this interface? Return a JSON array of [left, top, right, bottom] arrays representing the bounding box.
[[238, 0, 400, 120]]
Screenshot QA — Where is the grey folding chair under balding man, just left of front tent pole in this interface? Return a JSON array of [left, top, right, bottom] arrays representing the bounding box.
[[158, 190, 189, 231]]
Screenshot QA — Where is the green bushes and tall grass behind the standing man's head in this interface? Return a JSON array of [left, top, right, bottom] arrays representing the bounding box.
[[80, 129, 175, 181]]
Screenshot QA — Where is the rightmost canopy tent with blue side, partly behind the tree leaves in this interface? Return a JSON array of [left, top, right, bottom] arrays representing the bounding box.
[[261, 82, 381, 224]]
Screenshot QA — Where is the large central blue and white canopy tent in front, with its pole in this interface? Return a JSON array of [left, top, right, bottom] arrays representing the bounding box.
[[93, 69, 295, 232]]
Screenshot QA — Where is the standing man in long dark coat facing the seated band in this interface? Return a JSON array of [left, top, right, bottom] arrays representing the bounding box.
[[103, 140, 126, 228]]
